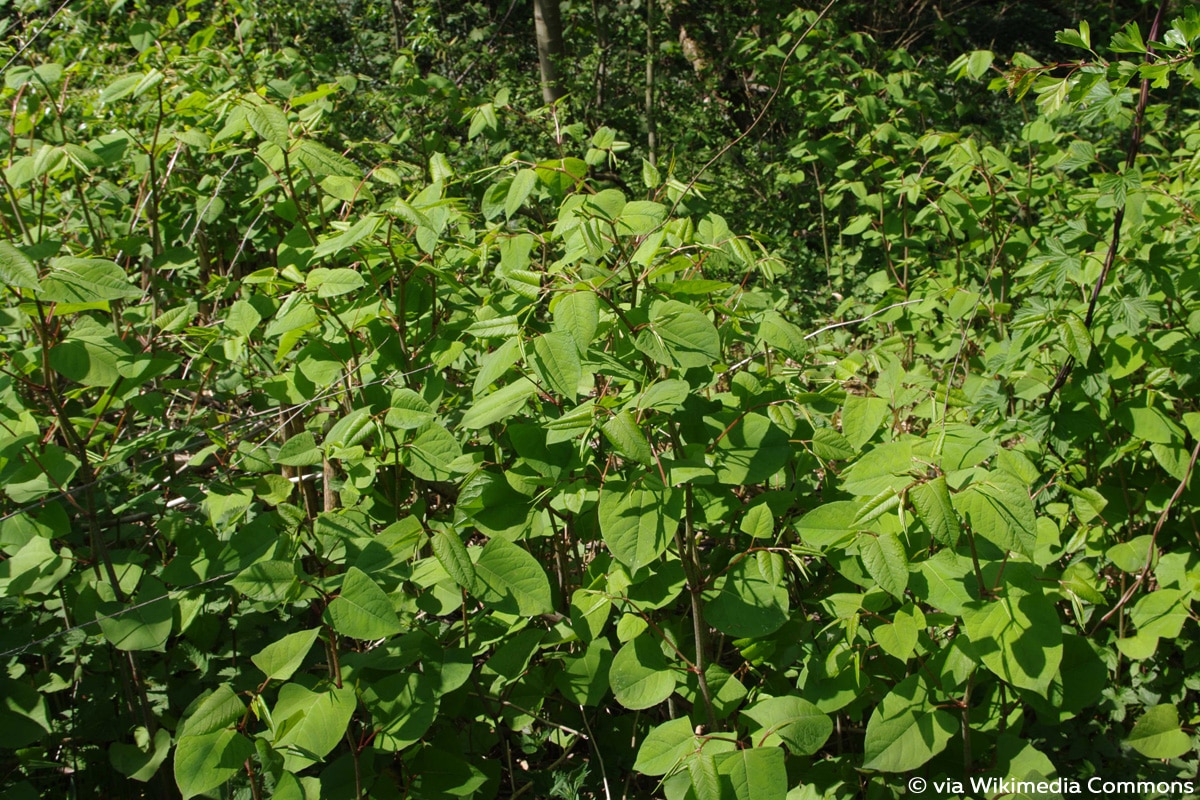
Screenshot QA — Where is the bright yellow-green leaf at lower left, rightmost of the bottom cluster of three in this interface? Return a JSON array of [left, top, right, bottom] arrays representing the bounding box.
[[271, 684, 359, 772]]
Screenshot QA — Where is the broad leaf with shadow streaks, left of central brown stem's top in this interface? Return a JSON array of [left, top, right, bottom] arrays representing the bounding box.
[[599, 481, 683, 572]]
